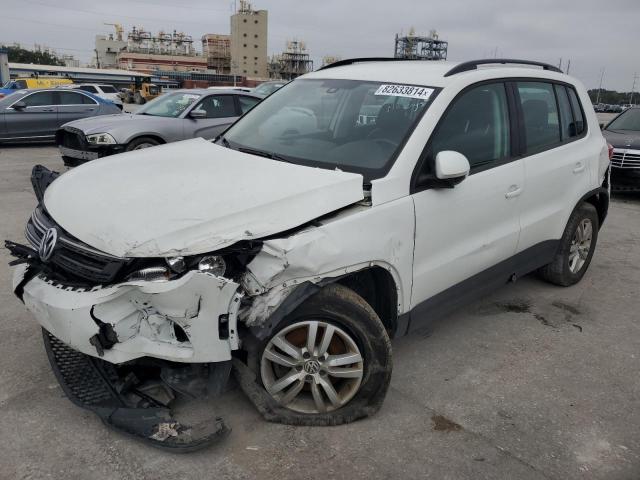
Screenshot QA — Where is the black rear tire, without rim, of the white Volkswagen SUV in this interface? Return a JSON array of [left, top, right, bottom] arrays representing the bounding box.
[[538, 203, 600, 287]]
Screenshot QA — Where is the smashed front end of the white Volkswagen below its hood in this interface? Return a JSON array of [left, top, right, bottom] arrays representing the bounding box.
[[5, 166, 390, 451]]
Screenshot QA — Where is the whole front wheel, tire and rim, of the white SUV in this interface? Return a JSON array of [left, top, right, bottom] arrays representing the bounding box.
[[249, 284, 392, 425]]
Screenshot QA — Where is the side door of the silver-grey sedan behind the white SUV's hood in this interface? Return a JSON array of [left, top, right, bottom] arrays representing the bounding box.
[[185, 95, 240, 139]]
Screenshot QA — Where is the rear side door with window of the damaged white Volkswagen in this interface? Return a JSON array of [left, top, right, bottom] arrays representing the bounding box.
[[513, 80, 599, 251]]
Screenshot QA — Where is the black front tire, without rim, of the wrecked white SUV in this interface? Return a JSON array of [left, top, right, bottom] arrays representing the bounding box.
[[247, 284, 393, 425]]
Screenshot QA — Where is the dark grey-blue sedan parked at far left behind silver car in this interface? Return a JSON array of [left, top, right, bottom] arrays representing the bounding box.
[[0, 88, 120, 142]]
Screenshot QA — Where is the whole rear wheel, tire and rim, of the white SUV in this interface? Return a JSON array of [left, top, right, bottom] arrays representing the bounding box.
[[539, 203, 600, 287]]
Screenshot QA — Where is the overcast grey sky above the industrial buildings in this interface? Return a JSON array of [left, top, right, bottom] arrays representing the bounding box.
[[0, 0, 640, 91]]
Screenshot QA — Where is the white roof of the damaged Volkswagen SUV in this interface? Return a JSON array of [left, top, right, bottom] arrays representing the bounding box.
[[299, 59, 570, 87]]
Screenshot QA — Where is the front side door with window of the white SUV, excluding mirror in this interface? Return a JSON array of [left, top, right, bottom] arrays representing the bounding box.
[[411, 83, 524, 326]]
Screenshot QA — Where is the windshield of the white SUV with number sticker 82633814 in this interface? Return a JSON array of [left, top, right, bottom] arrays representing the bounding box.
[[220, 79, 435, 181]]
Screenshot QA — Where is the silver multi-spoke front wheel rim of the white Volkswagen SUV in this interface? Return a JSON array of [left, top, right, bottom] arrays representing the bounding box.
[[260, 320, 364, 413]]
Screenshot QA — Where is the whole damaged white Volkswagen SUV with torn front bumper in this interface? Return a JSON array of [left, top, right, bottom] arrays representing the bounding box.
[[6, 59, 610, 451]]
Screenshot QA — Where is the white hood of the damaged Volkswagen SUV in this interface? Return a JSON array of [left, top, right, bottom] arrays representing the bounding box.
[[44, 138, 363, 257]]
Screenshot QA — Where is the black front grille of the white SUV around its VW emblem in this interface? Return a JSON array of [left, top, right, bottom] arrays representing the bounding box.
[[25, 206, 127, 284]]
